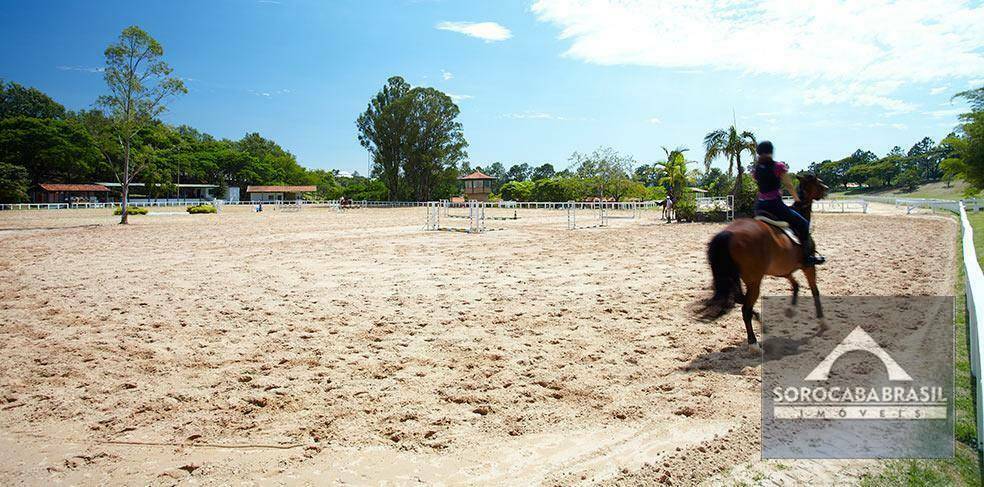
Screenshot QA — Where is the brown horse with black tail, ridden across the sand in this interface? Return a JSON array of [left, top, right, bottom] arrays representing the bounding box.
[[700, 174, 827, 345]]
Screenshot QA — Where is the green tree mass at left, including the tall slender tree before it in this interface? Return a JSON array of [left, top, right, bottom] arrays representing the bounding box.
[[0, 27, 387, 212]]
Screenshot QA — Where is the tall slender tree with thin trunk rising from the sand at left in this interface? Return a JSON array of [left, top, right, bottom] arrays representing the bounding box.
[[97, 25, 188, 224]]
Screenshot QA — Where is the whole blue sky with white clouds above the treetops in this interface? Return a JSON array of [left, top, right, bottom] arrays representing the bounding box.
[[0, 0, 984, 173]]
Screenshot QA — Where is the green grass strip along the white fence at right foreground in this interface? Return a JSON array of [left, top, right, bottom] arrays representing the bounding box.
[[861, 212, 984, 487]]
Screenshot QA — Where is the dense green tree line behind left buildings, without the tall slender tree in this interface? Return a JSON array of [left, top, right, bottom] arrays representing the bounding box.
[[0, 81, 385, 202]]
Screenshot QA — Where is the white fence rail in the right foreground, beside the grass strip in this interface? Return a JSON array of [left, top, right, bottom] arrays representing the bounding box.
[[958, 202, 984, 450]]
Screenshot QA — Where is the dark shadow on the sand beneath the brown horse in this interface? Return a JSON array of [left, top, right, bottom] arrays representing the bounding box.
[[684, 336, 815, 375]]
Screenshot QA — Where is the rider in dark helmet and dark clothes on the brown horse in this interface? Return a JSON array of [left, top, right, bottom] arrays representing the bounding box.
[[752, 140, 826, 267]]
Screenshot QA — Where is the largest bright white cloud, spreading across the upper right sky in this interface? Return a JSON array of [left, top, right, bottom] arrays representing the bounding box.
[[531, 0, 984, 112]]
